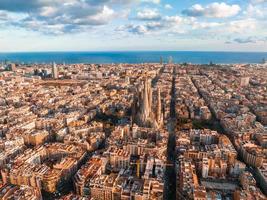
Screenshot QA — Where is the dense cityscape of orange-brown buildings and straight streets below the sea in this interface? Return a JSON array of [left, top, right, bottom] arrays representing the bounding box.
[[0, 59, 267, 200]]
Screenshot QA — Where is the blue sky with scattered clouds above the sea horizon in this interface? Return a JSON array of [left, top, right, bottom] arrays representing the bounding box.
[[0, 0, 267, 52]]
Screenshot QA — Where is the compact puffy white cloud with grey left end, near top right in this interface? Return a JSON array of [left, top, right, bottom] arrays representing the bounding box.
[[183, 2, 241, 18]]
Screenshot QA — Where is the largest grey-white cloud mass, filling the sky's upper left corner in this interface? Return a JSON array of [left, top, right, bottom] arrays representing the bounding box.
[[0, 0, 133, 34]]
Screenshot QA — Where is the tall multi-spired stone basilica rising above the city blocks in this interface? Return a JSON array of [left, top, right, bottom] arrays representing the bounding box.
[[132, 79, 163, 128]]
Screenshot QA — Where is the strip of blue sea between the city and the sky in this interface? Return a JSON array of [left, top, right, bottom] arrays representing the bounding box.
[[0, 51, 267, 64]]
